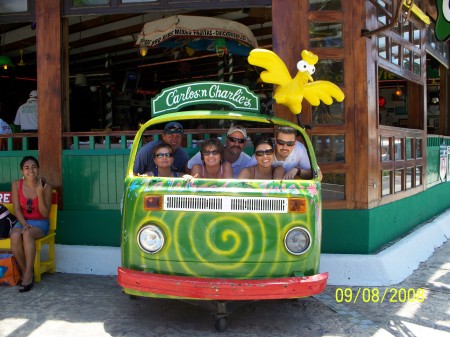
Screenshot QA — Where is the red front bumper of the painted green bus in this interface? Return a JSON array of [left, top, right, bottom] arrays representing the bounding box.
[[118, 267, 328, 301]]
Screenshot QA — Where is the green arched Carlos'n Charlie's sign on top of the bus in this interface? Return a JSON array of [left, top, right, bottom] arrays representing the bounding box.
[[152, 81, 259, 117]]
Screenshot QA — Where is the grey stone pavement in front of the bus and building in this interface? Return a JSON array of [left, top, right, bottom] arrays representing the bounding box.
[[0, 241, 450, 337]]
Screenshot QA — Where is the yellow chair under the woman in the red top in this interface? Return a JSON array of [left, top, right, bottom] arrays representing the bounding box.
[[0, 191, 58, 282]]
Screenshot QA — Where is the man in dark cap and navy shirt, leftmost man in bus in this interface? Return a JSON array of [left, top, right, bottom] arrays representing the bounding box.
[[133, 122, 189, 175]]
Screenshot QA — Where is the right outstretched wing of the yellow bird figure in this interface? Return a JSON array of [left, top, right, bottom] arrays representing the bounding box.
[[303, 81, 345, 106]]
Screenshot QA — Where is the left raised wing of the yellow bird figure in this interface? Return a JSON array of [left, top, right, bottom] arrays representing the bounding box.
[[248, 48, 292, 85]]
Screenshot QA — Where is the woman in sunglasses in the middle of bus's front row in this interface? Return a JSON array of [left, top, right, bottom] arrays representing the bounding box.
[[183, 139, 233, 180]]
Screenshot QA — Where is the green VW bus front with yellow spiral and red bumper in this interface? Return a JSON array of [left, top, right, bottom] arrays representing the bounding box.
[[118, 82, 328, 330]]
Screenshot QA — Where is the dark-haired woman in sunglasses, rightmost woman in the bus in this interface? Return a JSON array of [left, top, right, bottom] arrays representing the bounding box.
[[237, 137, 284, 180]]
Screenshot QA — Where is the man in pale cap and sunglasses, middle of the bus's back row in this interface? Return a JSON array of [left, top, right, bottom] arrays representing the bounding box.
[[187, 125, 251, 178]]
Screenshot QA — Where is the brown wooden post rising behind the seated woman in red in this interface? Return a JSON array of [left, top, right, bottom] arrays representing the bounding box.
[[36, 0, 63, 199]]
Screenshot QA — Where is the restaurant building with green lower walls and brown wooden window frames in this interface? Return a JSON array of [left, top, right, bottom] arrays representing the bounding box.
[[0, 0, 450, 278]]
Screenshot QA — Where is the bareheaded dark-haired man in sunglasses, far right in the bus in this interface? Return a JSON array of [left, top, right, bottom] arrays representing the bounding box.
[[273, 126, 311, 179]]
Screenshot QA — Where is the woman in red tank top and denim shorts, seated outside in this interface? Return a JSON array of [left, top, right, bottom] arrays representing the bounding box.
[[11, 156, 52, 292]]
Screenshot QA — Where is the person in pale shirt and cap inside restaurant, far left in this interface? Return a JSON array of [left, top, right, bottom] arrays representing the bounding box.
[[14, 90, 38, 149]]
